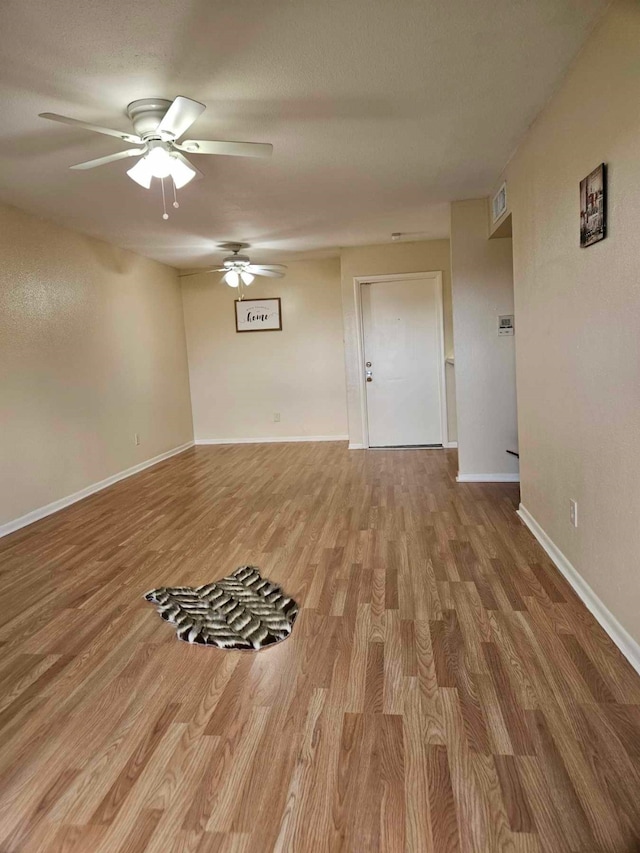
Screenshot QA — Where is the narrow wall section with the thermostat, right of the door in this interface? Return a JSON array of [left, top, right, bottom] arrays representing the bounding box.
[[451, 199, 518, 477]]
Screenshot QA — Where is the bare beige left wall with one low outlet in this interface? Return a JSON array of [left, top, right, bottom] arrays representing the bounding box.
[[0, 206, 192, 525]]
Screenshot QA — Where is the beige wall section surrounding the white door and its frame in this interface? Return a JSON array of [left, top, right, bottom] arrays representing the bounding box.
[[341, 240, 456, 444]]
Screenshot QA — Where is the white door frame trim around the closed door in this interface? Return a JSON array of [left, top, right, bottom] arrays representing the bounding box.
[[353, 270, 450, 449]]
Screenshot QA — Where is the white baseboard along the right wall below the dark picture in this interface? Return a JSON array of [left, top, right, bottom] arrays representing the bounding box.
[[518, 504, 640, 673]]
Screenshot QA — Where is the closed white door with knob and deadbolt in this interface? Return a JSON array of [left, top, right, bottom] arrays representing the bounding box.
[[360, 275, 444, 447]]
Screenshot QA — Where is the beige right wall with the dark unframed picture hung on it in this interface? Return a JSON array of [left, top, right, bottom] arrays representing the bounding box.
[[506, 0, 640, 641]]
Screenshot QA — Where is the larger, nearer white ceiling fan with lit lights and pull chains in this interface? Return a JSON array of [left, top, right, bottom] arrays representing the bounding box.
[[40, 95, 273, 219]]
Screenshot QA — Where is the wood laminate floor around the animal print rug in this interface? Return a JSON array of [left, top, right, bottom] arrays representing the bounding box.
[[0, 443, 640, 853]]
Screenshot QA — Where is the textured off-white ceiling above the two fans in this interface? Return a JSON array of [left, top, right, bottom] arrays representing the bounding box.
[[0, 0, 606, 267]]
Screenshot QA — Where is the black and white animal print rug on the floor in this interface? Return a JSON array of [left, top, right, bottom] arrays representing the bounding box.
[[145, 566, 298, 649]]
